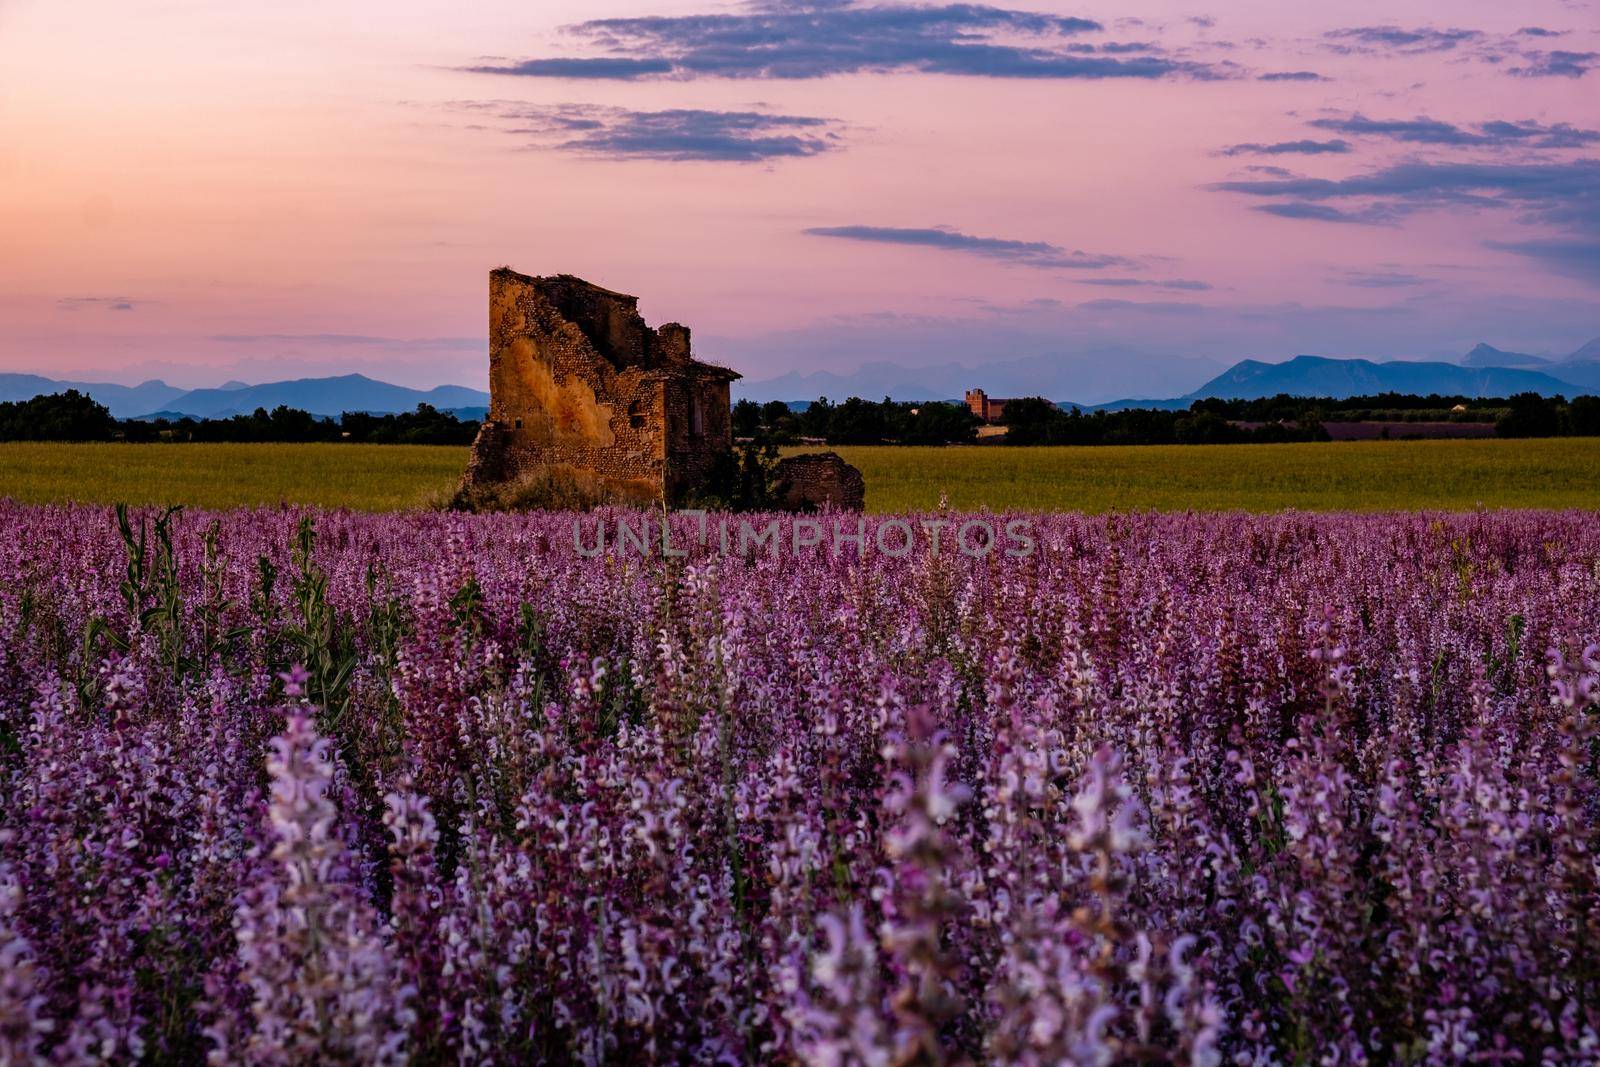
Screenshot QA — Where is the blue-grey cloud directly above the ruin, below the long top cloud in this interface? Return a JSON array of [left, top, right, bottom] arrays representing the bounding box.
[[453, 101, 842, 163]]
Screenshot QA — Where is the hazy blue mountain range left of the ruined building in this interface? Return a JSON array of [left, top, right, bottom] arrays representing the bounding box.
[[0, 374, 490, 419]]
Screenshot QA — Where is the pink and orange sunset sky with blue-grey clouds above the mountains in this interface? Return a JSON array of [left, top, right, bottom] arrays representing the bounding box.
[[0, 0, 1600, 400]]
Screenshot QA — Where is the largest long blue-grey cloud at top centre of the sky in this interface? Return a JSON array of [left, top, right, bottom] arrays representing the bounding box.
[[467, 0, 1224, 80]]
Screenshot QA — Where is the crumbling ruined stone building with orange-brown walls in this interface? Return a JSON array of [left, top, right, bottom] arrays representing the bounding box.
[[462, 267, 739, 501]]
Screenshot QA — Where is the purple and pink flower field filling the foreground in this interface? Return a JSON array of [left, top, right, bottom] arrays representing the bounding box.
[[0, 504, 1600, 1065]]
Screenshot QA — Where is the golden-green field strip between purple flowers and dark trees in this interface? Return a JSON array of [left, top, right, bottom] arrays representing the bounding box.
[[0, 438, 1600, 512]]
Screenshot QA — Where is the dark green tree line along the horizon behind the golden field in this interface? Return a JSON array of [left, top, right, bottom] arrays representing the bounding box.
[[0, 389, 1600, 445]]
